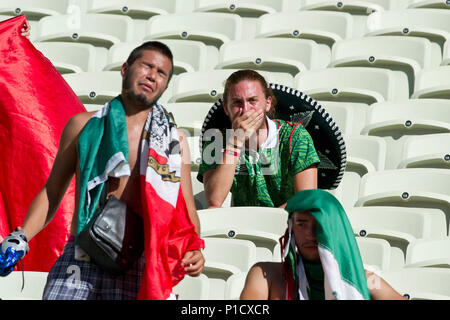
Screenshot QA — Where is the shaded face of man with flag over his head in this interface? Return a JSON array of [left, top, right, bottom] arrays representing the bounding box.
[[292, 212, 320, 263]]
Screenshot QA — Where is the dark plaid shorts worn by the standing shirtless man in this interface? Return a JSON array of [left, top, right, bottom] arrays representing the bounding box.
[[43, 238, 145, 300]]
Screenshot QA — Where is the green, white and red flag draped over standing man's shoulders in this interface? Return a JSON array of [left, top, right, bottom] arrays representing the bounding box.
[[77, 96, 204, 300]]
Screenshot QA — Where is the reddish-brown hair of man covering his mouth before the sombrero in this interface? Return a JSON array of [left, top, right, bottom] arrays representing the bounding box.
[[223, 69, 277, 118]]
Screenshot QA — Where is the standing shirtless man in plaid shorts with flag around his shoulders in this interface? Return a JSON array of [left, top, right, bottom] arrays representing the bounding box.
[[0, 40, 204, 300]]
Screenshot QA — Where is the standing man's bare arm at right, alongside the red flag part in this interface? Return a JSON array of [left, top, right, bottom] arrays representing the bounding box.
[[178, 129, 200, 235]]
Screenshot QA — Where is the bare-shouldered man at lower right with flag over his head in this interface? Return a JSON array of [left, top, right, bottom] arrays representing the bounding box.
[[240, 189, 406, 300]]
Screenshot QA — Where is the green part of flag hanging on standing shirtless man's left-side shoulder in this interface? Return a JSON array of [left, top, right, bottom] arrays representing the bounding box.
[[77, 96, 129, 234]]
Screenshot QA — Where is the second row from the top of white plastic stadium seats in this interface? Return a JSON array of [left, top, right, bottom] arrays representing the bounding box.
[[0, 9, 450, 48]]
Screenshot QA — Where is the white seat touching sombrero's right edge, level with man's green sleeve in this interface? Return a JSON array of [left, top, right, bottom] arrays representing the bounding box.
[[344, 135, 386, 176]]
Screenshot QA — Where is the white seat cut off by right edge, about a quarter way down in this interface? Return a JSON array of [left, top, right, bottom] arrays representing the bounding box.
[[411, 66, 450, 99]]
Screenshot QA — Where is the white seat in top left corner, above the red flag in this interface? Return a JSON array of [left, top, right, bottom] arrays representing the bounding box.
[[0, 0, 69, 20]]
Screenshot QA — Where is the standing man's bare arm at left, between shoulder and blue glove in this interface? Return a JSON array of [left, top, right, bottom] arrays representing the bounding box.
[[22, 112, 92, 241]]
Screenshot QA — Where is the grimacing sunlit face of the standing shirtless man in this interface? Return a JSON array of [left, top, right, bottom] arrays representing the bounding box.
[[121, 50, 172, 107]]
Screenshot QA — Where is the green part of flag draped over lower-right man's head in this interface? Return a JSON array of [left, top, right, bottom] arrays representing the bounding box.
[[285, 189, 370, 299]]
